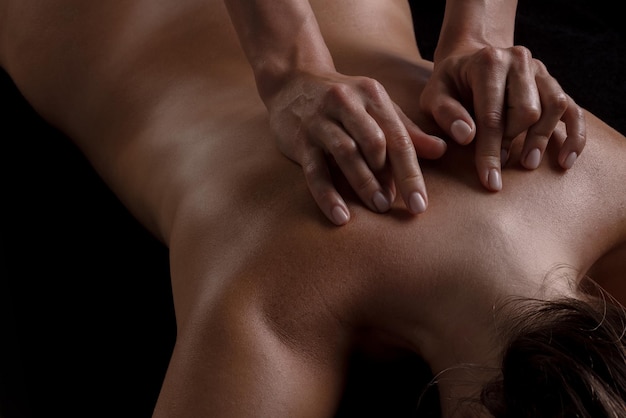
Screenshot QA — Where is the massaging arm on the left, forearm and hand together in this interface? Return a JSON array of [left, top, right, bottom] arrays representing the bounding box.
[[226, 0, 445, 225]]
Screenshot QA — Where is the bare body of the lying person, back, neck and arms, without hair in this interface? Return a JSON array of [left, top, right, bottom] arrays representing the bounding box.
[[0, 0, 626, 417]]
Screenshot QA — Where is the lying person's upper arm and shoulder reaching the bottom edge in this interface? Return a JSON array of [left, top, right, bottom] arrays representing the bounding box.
[[155, 272, 345, 417]]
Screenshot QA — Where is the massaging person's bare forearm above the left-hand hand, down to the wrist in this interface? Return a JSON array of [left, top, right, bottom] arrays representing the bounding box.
[[225, 0, 334, 100]]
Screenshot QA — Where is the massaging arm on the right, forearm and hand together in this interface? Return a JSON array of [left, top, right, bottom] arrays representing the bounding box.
[[421, 0, 585, 191]]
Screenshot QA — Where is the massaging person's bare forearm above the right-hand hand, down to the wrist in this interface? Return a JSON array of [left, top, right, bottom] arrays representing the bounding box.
[[435, 0, 517, 62]]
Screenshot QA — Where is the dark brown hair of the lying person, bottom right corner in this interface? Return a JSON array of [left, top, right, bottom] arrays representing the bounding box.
[[480, 293, 626, 418]]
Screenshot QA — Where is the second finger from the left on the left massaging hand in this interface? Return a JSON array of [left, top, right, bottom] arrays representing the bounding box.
[[316, 124, 391, 212]]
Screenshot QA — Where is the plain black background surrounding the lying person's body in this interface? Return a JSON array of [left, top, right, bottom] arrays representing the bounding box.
[[0, 0, 626, 418]]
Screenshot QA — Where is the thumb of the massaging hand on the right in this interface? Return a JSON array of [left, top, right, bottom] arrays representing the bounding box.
[[420, 82, 476, 145]]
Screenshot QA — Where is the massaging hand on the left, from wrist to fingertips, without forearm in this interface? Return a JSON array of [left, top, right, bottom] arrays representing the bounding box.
[[265, 71, 446, 225]]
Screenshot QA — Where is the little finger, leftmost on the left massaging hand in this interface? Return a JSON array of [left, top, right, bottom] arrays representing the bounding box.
[[301, 148, 350, 226]]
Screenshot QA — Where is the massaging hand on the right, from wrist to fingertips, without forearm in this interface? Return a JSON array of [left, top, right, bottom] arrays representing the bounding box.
[[420, 46, 585, 191]]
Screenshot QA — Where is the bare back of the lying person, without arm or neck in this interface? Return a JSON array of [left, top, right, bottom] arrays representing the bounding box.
[[1, 1, 624, 414]]
